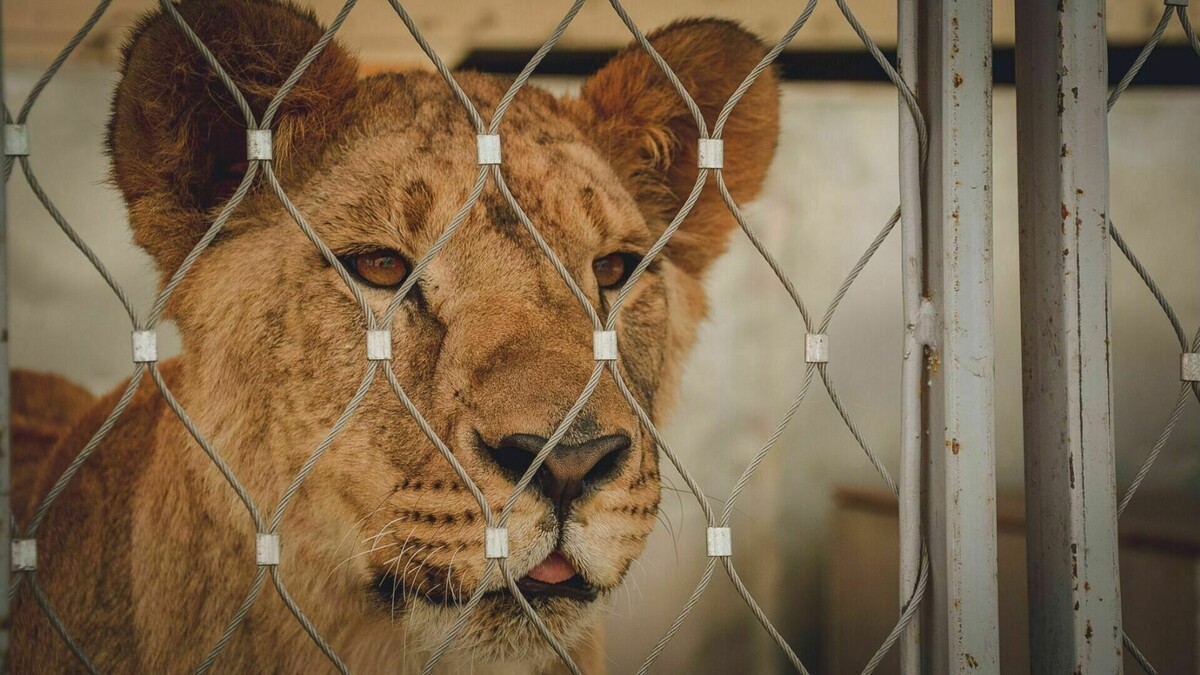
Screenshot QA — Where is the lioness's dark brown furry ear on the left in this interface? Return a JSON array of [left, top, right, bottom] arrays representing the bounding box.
[[108, 0, 358, 274]]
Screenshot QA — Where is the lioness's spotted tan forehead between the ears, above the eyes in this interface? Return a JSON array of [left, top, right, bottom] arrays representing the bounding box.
[[300, 73, 653, 253]]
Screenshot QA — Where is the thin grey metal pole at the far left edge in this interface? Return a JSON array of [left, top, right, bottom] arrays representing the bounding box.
[[0, 2, 12, 674]]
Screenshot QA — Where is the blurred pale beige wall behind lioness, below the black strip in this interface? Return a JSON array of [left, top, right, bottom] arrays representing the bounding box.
[[5, 67, 1200, 674]]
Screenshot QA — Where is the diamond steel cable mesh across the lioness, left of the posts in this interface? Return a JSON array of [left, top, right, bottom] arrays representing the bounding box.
[[5, 0, 926, 673]]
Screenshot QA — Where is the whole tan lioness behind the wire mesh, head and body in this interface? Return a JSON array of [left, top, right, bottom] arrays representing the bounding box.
[[12, 0, 779, 674]]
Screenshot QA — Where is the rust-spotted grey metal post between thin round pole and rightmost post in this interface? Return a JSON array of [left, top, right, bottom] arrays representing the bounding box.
[[917, 0, 1000, 674]]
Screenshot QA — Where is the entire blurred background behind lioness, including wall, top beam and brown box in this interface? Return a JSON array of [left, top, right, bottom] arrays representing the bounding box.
[[2, 0, 1200, 674]]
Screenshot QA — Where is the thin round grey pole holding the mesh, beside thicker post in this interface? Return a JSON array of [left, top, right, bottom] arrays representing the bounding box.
[[896, 0, 934, 675]]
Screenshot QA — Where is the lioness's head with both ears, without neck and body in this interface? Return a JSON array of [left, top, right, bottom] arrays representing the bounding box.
[[109, 1, 778, 658]]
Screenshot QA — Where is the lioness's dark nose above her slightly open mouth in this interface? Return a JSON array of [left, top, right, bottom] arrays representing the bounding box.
[[486, 434, 630, 510]]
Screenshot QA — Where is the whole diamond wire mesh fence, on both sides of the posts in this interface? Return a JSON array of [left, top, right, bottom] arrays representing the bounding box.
[[42, 0, 1200, 673]]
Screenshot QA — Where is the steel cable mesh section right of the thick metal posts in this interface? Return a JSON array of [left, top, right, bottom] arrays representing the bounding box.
[[1108, 5, 1200, 675]]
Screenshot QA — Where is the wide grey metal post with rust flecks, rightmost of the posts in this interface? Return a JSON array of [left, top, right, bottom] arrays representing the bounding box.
[[1016, 0, 1122, 675]]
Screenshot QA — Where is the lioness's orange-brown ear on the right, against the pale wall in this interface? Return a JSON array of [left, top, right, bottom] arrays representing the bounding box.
[[568, 19, 779, 274]]
